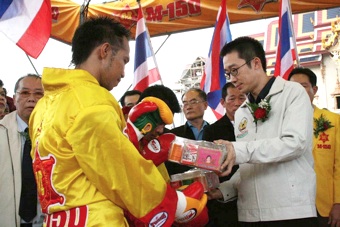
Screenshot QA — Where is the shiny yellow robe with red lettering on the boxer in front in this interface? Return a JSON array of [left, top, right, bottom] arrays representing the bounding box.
[[29, 68, 174, 226]]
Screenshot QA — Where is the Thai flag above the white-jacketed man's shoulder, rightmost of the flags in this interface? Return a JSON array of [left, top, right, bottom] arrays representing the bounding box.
[[274, 0, 297, 80]]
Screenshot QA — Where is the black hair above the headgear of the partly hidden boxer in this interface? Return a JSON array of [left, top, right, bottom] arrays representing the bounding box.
[[139, 84, 181, 114]]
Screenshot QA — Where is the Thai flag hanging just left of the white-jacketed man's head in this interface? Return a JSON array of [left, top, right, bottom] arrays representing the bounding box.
[[201, 0, 232, 119]]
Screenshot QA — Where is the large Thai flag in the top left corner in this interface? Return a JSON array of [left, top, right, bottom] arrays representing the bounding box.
[[0, 0, 52, 58]]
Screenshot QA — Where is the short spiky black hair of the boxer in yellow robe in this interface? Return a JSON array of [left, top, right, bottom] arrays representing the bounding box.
[[71, 17, 130, 65]]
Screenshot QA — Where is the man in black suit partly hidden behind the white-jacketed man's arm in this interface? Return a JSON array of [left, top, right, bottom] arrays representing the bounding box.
[[203, 82, 246, 227]]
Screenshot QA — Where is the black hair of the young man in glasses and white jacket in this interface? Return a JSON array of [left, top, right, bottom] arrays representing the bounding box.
[[220, 36, 267, 72]]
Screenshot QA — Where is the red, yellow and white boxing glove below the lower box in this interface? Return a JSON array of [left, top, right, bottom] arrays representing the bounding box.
[[176, 181, 209, 227]]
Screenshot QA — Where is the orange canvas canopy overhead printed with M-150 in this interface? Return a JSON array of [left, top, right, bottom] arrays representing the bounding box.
[[51, 0, 340, 43]]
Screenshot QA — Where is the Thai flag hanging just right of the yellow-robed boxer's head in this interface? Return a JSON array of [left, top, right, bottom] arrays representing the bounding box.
[[132, 5, 161, 91]]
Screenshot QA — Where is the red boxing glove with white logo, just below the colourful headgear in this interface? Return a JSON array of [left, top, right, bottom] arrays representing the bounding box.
[[140, 133, 176, 166]]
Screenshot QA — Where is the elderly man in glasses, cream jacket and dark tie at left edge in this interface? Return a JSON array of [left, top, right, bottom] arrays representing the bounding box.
[[0, 74, 44, 227]]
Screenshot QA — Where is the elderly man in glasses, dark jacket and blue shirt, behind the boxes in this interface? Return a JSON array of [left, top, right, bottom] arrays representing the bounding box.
[[165, 88, 208, 175]]
